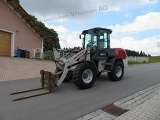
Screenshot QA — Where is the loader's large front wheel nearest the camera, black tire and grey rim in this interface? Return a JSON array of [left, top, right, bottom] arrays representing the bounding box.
[[73, 63, 96, 89]]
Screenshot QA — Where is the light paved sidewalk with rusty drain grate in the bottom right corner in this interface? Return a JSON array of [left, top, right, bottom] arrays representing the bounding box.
[[77, 83, 160, 120]]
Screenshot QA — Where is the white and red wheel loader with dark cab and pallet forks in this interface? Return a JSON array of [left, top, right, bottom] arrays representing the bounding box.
[[12, 27, 128, 100]]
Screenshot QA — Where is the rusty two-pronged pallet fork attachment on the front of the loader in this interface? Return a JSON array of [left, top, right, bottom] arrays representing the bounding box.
[[10, 70, 54, 101]]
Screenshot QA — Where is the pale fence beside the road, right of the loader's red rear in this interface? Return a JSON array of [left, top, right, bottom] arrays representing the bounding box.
[[128, 56, 149, 62]]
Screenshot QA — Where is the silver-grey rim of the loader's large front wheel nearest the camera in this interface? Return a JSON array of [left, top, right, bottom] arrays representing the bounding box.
[[82, 69, 93, 83]]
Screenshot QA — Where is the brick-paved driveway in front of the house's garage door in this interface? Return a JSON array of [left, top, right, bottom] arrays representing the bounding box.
[[0, 57, 55, 81]]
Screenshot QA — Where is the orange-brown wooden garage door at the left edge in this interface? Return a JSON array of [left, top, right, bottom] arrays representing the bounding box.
[[0, 31, 11, 56]]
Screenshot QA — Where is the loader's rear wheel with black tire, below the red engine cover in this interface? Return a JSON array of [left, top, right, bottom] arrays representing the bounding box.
[[108, 62, 124, 81]]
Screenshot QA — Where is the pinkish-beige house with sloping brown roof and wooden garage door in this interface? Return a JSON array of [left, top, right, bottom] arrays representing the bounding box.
[[0, 0, 50, 57]]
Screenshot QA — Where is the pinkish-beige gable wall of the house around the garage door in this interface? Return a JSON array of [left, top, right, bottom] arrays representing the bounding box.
[[0, 0, 42, 56]]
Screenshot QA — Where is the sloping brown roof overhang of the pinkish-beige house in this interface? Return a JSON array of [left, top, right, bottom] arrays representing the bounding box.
[[4, 0, 51, 43]]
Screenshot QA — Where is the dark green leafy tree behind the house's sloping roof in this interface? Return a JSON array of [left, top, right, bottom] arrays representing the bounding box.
[[30, 15, 60, 51]]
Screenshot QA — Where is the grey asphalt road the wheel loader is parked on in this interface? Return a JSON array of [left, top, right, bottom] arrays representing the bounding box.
[[0, 63, 160, 120]]
